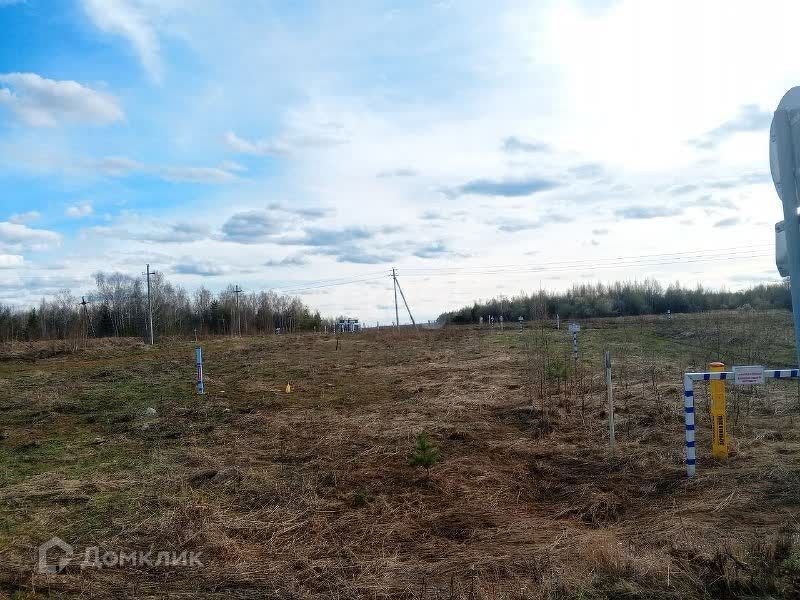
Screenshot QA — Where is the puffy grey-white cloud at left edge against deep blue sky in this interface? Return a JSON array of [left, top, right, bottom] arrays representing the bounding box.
[[0, 73, 125, 127]]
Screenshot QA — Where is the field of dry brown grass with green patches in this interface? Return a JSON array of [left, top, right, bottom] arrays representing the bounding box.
[[0, 312, 800, 599]]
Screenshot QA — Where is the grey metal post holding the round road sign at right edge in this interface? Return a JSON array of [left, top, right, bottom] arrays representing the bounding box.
[[773, 109, 800, 365]]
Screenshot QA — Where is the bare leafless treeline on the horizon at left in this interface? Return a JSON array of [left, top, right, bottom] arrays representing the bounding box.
[[0, 272, 332, 342]]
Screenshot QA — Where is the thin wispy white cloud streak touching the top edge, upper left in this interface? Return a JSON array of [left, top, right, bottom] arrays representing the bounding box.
[[83, 0, 163, 82]]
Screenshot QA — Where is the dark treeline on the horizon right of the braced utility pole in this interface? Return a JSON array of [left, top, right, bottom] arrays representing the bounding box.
[[437, 279, 792, 325]]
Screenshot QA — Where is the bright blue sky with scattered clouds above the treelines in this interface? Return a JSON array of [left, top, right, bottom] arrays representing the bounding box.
[[0, 0, 800, 323]]
